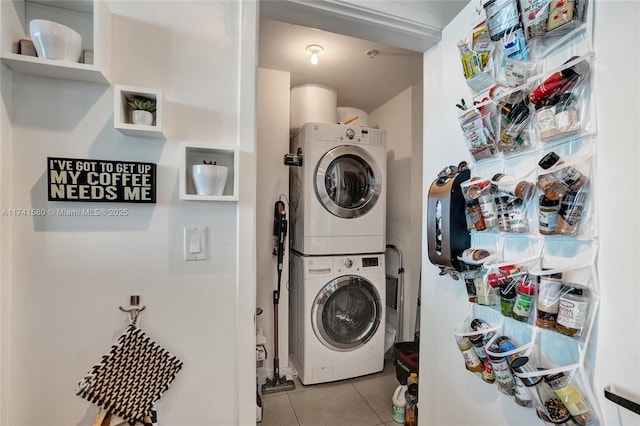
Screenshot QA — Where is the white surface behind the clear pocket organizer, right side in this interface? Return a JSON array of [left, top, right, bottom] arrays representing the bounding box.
[[420, 1, 640, 425]]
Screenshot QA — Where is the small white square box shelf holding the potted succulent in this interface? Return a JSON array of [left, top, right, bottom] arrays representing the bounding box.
[[113, 85, 166, 138]]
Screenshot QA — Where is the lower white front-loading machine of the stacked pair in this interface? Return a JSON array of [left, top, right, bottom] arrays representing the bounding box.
[[289, 254, 385, 385]]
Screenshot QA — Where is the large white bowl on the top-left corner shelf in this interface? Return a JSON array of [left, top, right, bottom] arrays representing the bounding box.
[[29, 19, 82, 62]]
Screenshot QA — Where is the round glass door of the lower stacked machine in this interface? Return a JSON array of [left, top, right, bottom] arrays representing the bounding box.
[[311, 275, 382, 351]]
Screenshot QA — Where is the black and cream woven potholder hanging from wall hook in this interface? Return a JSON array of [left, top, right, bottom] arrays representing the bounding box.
[[76, 296, 182, 426]]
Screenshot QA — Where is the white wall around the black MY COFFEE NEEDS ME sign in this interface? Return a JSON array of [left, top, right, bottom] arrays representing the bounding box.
[[0, 1, 256, 426]]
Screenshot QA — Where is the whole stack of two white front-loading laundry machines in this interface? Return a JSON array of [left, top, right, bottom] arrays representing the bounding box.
[[289, 116, 386, 385]]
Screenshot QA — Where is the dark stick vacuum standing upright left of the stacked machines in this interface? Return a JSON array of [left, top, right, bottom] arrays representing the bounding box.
[[262, 200, 296, 394]]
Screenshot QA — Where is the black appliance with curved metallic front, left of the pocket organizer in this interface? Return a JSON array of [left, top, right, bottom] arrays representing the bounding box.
[[427, 162, 471, 277]]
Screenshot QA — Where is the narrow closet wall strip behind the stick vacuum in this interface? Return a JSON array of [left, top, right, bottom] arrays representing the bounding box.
[[256, 68, 291, 382]]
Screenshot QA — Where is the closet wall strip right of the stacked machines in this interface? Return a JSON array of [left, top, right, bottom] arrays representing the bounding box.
[[369, 86, 422, 341]]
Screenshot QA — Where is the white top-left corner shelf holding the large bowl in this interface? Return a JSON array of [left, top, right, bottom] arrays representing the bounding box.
[[0, 0, 111, 84]]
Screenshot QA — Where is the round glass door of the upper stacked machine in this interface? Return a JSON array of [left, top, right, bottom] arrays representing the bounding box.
[[315, 145, 382, 219]]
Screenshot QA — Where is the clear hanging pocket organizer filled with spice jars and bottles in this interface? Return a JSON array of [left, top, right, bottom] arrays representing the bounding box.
[[442, 0, 602, 425]]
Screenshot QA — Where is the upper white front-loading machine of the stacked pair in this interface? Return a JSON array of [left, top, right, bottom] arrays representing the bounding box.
[[289, 123, 387, 255]]
